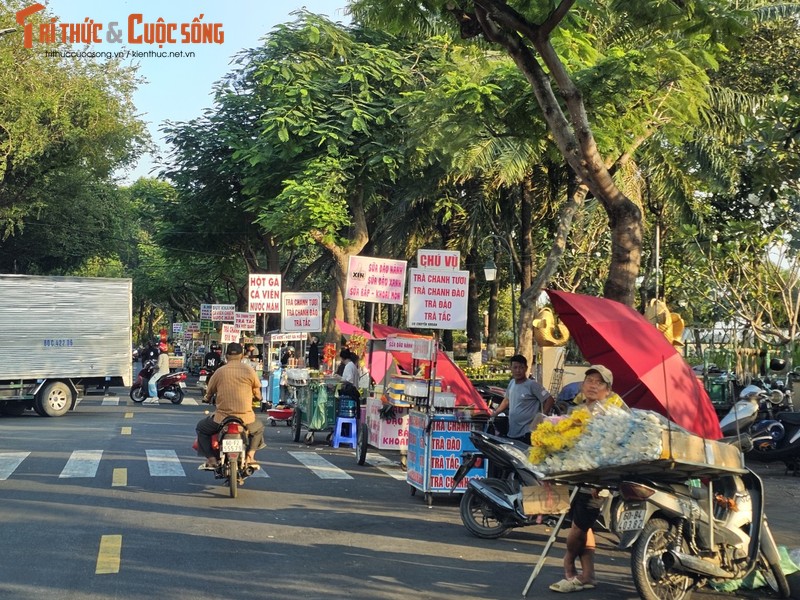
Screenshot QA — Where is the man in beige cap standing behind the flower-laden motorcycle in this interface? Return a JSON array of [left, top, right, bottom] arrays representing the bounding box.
[[550, 365, 627, 593]]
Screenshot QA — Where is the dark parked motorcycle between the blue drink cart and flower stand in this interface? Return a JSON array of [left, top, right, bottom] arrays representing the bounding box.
[[451, 431, 620, 539]]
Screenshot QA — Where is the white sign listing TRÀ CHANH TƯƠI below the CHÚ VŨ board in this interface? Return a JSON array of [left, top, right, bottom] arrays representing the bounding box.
[[408, 269, 469, 329]]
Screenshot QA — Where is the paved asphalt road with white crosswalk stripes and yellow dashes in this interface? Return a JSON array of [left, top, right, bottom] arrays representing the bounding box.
[[0, 389, 800, 600]]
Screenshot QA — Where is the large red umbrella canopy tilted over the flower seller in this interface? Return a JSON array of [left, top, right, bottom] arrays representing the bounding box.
[[547, 291, 722, 440]]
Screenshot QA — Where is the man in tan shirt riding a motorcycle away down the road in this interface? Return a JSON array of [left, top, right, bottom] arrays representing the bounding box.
[[196, 343, 264, 470]]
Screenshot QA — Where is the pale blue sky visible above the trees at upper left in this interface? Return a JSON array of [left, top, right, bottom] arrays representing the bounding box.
[[43, 0, 349, 183]]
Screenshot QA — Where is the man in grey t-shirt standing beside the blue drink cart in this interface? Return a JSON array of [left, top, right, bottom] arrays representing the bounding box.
[[492, 354, 555, 444]]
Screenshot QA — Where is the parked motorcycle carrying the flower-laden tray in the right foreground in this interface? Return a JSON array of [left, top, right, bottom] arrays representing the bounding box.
[[617, 446, 791, 600]]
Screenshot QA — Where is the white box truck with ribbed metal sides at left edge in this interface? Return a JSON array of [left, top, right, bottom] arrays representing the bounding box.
[[0, 274, 132, 417]]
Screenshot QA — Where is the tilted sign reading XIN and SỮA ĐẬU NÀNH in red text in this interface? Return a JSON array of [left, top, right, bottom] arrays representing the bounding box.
[[344, 255, 406, 304]]
